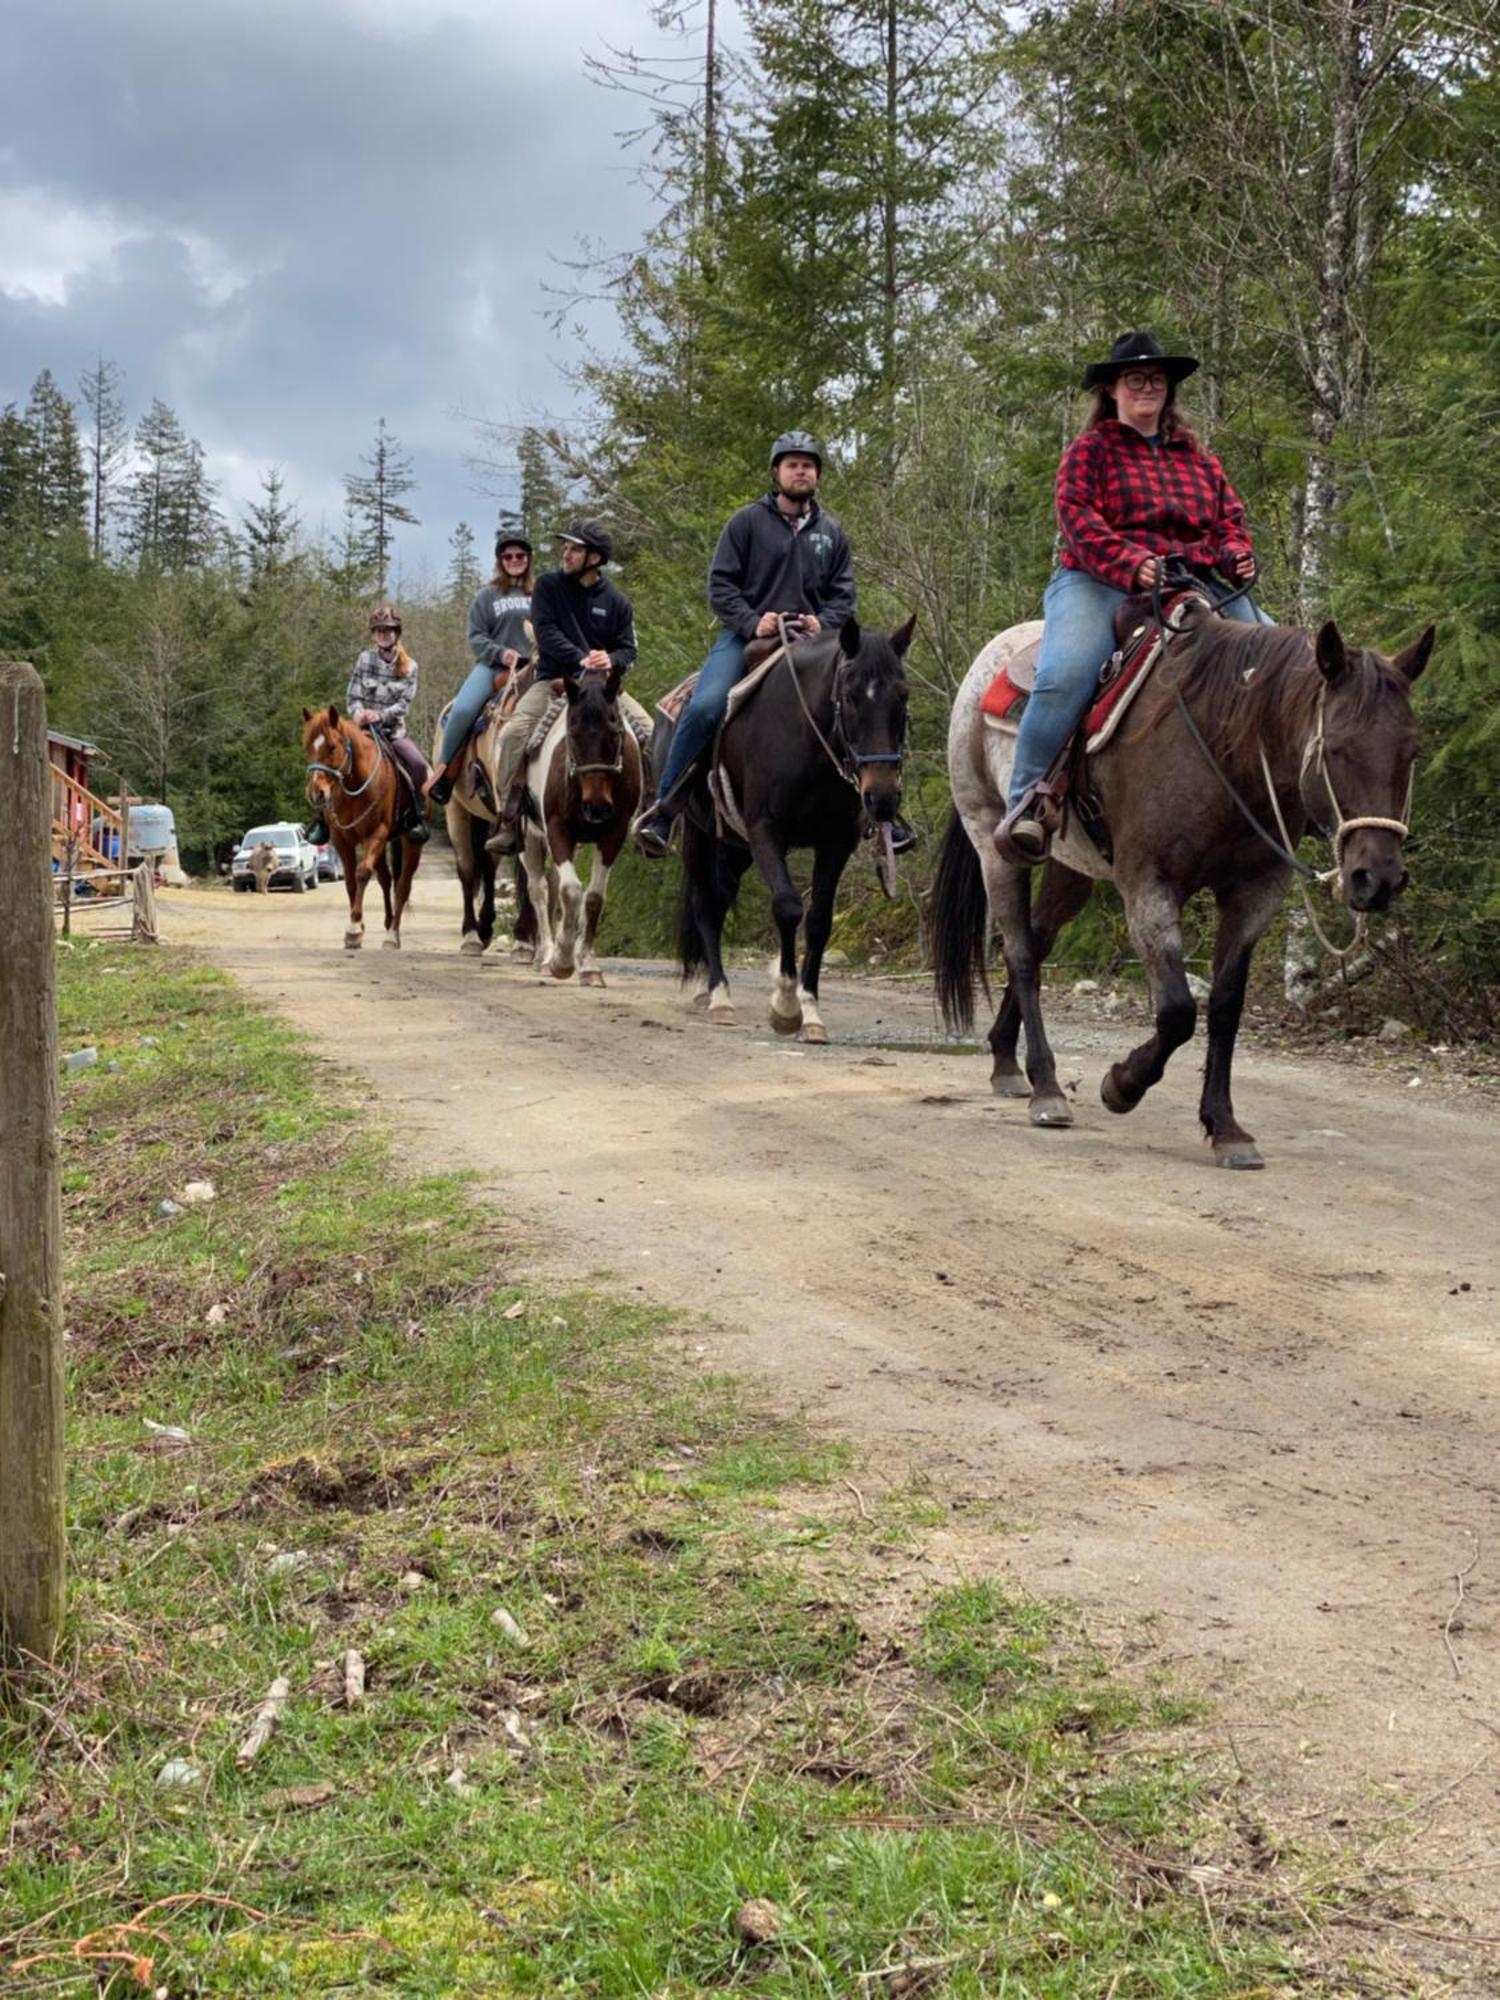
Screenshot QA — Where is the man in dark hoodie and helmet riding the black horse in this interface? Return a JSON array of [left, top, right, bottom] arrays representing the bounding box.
[[636, 430, 854, 858]]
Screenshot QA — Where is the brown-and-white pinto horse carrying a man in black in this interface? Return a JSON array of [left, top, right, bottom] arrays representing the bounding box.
[[526, 666, 642, 986]]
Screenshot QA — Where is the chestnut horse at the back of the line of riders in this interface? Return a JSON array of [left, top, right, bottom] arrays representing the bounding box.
[[302, 704, 422, 952]]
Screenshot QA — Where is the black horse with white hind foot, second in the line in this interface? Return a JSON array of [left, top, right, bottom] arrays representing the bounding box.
[[672, 618, 916, 1042]]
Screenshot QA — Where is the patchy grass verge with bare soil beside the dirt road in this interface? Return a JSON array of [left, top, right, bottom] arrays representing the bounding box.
[[0, 948, 1372, 2000]]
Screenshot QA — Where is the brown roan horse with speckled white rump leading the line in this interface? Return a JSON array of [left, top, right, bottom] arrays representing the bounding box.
[[932, 604, 1434, 1168]]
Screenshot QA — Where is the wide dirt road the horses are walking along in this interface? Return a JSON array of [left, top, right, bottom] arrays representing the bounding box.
[[150, 866, 1500, 1930]]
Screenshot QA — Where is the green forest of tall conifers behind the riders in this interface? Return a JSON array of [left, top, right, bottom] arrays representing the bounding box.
[[0, 0, 1500, 1034]]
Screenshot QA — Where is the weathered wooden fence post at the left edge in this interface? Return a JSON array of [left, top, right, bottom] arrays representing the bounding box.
[[0, 662, 64, 1658]]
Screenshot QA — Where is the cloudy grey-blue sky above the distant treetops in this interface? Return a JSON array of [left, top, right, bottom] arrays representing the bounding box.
[[0, 0, 724, 582]]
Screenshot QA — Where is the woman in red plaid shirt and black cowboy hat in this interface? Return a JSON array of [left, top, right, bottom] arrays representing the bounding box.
[[996, 332, 1270, 862]]
